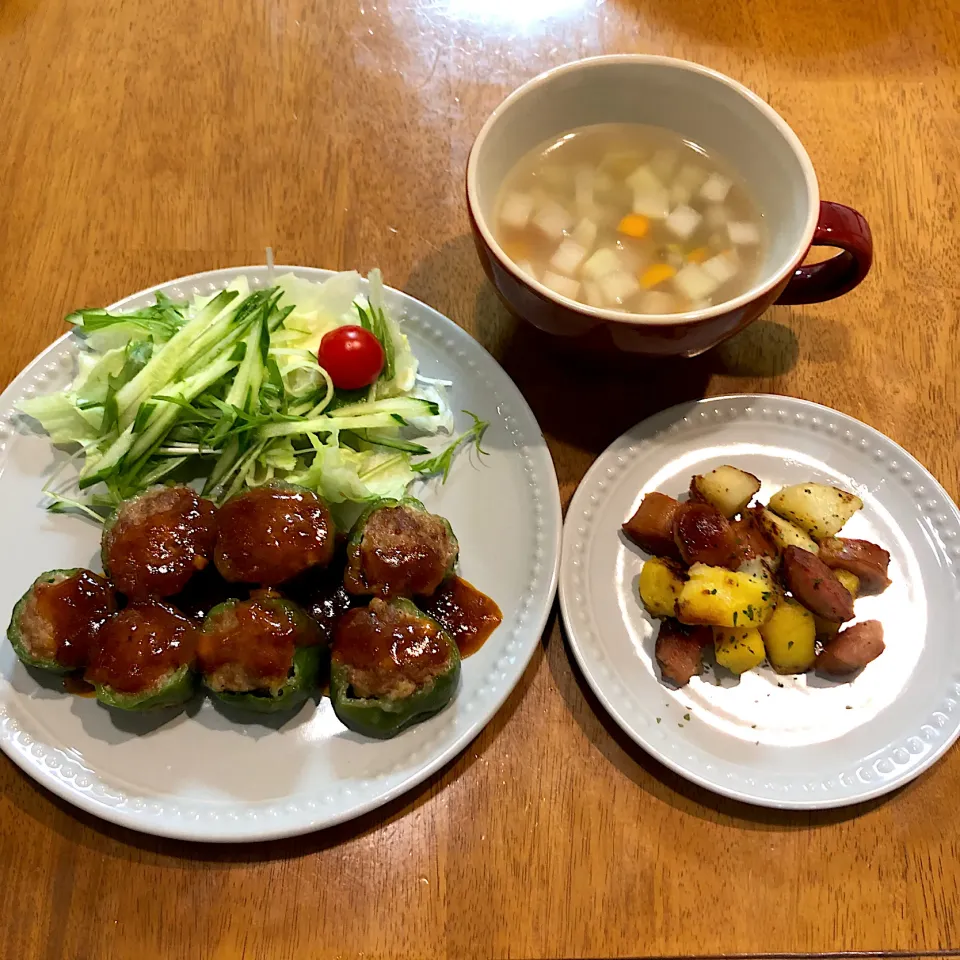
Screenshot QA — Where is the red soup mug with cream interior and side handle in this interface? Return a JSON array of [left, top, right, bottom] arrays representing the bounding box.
[[467, 55, 873, 357]]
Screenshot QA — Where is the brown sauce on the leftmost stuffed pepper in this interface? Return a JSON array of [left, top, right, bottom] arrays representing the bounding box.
[[33, 570, 117, 668]]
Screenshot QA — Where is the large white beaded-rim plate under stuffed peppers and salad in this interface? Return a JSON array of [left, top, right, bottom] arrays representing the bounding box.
[[0, 267, 561, 841]]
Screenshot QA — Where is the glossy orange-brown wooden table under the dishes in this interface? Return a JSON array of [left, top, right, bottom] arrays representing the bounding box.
[[0, 0, 960, 960]]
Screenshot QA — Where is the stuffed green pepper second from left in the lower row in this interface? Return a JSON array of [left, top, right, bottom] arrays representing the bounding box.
[[86, 600, 197, 710]]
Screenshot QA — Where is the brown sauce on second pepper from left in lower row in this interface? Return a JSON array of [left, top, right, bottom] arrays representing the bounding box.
[[86, 600, 197, 693]]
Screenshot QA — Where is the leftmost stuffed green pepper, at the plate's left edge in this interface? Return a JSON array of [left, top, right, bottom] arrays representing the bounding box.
[[7, 568, 117, 673]]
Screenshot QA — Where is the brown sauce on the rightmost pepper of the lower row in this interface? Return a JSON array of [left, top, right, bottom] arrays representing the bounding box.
[[333, 599, 449, 674]]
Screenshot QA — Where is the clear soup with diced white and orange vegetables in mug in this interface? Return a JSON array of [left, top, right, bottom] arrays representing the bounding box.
[[494, 123, 767, 314]]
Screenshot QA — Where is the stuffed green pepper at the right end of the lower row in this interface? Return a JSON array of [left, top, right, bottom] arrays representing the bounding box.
[[330, 598, 460, 739]]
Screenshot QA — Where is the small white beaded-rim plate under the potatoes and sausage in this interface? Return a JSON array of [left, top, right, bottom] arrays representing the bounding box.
[[560, 395, 960, 809]]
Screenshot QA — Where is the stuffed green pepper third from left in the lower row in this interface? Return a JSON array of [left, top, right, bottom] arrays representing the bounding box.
[[198, 591, 327, 713]]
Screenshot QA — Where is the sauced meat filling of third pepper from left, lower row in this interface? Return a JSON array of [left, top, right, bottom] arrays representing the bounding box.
[[197, 596, 321, 696]]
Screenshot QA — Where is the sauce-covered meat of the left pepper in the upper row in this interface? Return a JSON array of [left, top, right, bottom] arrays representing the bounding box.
[[104, 487, 216, 600]]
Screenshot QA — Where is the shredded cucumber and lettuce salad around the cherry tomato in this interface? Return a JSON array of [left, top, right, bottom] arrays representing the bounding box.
[[19, 270, 487, 517]]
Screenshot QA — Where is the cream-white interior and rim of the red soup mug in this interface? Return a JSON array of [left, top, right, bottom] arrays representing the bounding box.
[[467, 54, 820, 326]]
